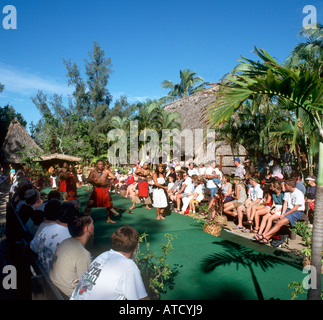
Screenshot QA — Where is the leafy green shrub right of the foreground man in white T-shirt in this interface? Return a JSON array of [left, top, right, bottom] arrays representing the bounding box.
[[134, 233, 177, 297]]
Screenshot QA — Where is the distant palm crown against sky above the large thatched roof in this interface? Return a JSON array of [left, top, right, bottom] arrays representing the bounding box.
[[161, 69, 207, 103]]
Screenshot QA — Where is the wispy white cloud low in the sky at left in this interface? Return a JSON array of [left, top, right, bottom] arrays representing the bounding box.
[[0, 64, 71, 96]]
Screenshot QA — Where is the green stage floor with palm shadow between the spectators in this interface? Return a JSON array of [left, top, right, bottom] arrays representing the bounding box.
[[44, 189, 306, 300]]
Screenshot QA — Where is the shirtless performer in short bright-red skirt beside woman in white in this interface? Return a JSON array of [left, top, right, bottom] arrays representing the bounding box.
[[130, 162, 152, 210]]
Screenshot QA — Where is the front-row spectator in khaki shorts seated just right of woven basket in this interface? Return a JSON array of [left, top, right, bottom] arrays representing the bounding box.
[[223, 176, 247, 230]]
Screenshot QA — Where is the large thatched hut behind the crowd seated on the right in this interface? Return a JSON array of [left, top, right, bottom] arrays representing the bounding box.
[[165, 85, 246, 174]]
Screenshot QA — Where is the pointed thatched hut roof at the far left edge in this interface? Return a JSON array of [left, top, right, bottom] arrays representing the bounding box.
[[0, 119, 43, 163]]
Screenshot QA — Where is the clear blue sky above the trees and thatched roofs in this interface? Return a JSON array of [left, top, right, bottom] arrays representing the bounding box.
[[0, 0, 323, 130]]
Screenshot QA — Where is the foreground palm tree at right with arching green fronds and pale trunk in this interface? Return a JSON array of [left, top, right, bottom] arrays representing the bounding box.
[[206, 48, 323, 299]]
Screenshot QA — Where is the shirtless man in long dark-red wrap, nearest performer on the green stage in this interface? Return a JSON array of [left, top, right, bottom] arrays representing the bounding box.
[[85, 160, 116, 223]]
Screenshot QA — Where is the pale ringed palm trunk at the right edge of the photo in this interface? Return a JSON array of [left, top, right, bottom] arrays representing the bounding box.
[[308, 136, 323, 300]]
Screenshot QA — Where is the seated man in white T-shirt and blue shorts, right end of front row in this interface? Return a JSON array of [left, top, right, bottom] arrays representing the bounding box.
[[258, 179, 305, 244]]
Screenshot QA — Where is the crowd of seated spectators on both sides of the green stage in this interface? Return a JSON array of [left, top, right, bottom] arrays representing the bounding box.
[[3, 148, 316, 299]]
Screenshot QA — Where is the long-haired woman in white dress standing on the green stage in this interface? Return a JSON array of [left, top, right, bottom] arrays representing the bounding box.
[[153, 164, 168, 220]]
